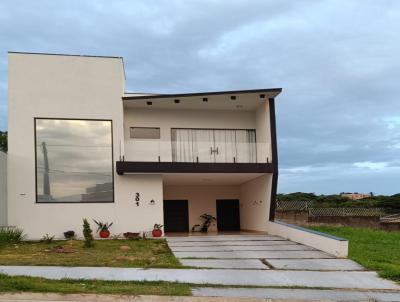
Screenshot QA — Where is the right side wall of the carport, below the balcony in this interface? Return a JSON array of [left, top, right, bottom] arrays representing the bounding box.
[[240, 174, 272, 231]]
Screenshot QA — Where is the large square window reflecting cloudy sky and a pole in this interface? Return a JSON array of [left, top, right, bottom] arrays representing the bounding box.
[[35, 118, 114, 203]]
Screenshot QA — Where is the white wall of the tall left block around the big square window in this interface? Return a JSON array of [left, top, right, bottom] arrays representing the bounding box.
[[8, 53, 163, 239]]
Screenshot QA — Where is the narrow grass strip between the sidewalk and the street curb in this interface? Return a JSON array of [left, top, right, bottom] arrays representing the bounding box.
[[0, 274, 191, 296]]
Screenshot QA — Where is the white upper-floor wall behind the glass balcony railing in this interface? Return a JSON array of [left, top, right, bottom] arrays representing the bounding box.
[[124, 105, 270, 162]]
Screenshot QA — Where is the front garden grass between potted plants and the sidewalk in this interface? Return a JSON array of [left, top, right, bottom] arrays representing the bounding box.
[[0, 240, 182, 268]]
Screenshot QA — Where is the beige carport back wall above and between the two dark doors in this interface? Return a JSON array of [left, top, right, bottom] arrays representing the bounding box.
[[164, 186, 240, 231]]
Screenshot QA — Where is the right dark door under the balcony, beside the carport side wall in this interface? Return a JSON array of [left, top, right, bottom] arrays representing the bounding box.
[[217, 199, 240, 231]]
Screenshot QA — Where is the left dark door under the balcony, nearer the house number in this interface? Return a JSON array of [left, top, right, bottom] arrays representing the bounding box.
[[164, 200, 189, 232]]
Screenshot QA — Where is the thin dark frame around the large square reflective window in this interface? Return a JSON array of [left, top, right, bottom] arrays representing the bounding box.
[[33, 117, 115, 204]]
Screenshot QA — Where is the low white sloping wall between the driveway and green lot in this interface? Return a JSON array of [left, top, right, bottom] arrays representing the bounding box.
[[267, 221, 349, 258]]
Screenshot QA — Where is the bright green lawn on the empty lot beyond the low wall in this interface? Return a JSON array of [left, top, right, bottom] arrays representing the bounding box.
[[309, 225, 400, 282]]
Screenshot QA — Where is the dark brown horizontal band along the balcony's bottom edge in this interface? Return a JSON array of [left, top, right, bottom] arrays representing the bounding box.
[[116, 161, 274, 175]]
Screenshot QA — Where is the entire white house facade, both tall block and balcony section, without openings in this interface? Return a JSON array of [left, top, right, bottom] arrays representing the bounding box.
[[7, 53, 280, 239]]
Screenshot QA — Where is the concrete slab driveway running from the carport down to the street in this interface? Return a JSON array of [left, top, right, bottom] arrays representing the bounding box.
[[167, 235, 400, 301]]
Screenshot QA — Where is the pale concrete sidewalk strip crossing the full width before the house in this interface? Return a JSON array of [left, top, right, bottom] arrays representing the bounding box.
[[0, 266, 400, 290]]
